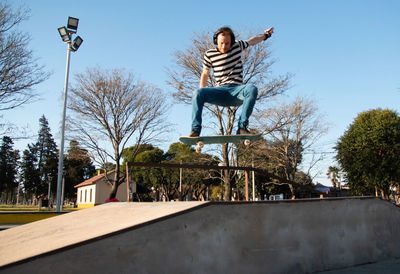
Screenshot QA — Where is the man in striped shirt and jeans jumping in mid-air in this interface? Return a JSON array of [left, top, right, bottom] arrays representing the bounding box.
[[189, 27, 274, 137]]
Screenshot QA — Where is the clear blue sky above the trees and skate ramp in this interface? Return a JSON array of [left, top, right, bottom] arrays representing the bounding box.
[[2, 0, 400, 184]]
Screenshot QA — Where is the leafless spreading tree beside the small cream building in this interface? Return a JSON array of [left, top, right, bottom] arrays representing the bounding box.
[[69, 66, 166, 199]]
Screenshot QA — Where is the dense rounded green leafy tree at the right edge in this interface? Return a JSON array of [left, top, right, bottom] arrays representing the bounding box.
[[335, 108, 400, 198]]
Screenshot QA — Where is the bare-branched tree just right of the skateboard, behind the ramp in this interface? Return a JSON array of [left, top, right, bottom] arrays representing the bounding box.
[[257, 97, 328, 198]]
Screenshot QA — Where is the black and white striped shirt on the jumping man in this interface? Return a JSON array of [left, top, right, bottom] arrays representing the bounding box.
[[203, 40, 249, 86]]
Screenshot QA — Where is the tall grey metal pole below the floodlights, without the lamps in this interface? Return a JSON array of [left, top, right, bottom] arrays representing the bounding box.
[[56, 43, 71, 212]]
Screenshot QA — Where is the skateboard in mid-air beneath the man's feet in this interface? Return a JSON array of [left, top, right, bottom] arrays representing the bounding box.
[[179, 134, 261, 153]]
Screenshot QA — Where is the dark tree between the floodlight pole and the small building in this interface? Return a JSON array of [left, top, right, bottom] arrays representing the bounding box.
[[64, 140, 96, 199]]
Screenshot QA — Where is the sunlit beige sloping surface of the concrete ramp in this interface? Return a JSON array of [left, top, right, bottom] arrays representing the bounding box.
[[0, 202, 203, 266]]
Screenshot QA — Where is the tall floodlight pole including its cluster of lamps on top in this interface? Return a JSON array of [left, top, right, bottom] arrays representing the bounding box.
[[56, 17, 83, 212]]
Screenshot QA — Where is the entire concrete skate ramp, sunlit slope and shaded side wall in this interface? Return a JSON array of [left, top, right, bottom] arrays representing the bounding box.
[[0, 198, 400, 273]]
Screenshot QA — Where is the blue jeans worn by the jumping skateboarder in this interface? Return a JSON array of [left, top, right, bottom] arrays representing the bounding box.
[[192, 84, 258, 132]]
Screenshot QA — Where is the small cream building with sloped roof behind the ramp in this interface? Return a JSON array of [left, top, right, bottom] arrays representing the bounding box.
[[74, 170, 131, 208]]
